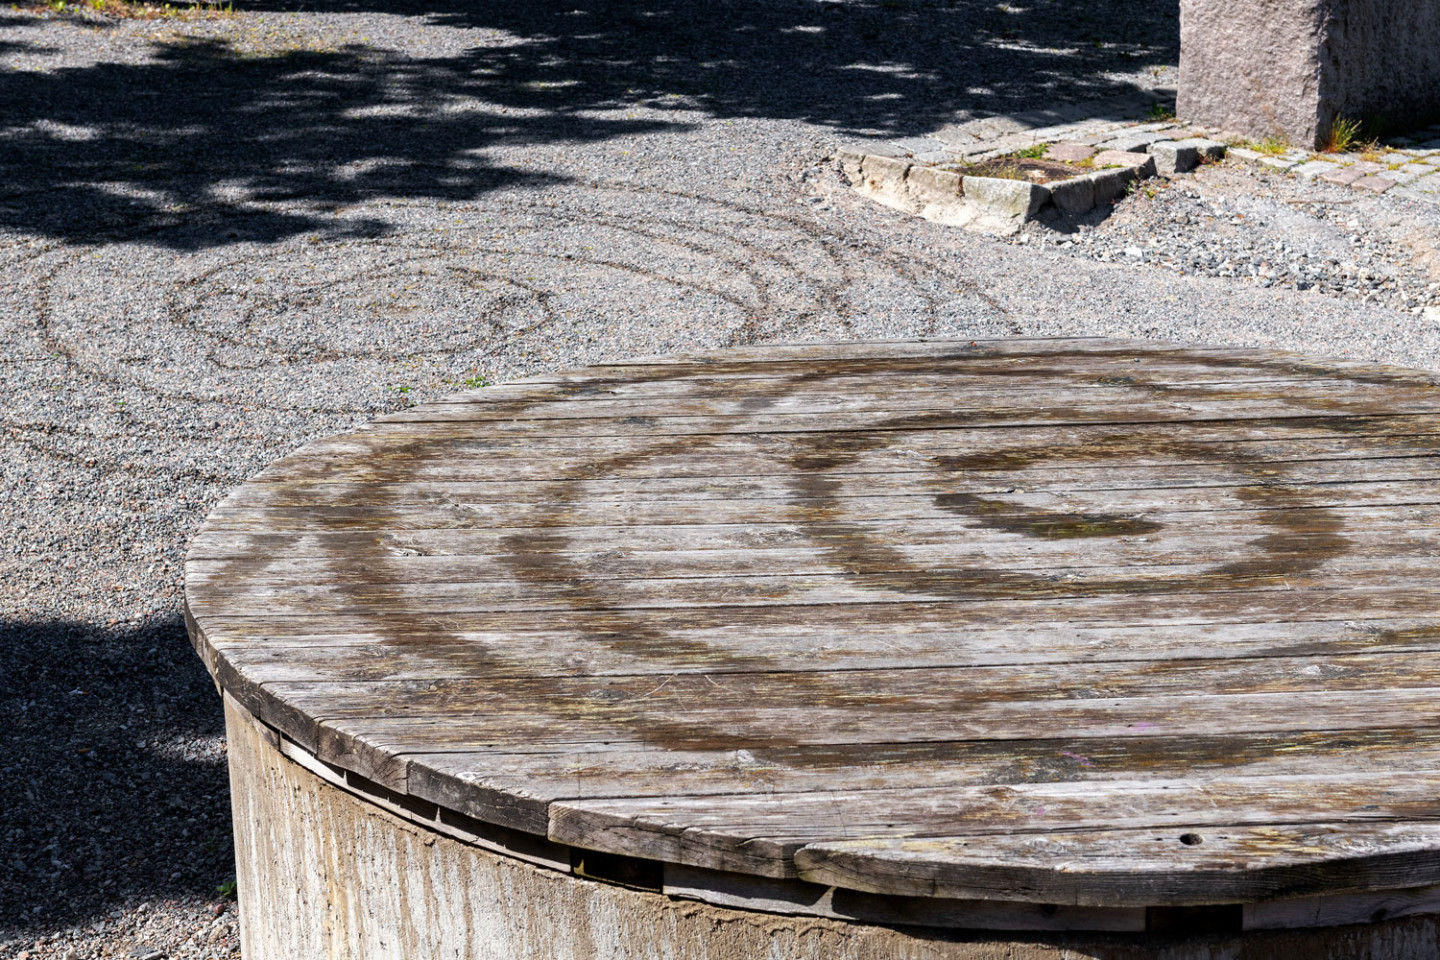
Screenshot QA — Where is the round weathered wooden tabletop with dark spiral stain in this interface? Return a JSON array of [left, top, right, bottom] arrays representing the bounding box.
[[186, 340, 1440, 907]]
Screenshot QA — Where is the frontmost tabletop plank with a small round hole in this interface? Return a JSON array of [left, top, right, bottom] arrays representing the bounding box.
[[795, 822, 1440, 925]]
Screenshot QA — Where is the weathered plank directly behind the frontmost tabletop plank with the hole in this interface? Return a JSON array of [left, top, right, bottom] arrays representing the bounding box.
[[550, 771, 1440, 886]]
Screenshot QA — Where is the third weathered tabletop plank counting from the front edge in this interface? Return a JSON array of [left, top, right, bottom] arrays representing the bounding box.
[[399, 727, 1440, 820]]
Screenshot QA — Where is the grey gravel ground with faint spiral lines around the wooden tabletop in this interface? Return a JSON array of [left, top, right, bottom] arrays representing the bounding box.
[[0, 0, 1440, 959]]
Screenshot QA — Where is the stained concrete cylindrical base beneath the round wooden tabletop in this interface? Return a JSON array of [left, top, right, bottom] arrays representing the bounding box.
[[226, 698, 1440, 960]]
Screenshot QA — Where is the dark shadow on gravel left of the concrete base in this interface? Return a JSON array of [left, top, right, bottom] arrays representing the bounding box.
[[0, 616, 235, 930]]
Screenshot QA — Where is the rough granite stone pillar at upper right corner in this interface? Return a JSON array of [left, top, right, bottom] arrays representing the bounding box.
[[1178, 0, 1440, 147]]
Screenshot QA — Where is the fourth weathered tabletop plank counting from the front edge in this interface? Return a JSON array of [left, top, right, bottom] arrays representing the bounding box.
[[259, 679, 1440, 782]]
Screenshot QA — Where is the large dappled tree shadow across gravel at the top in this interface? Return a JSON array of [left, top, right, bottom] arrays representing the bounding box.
[[0, 0, 1178, 248]]
